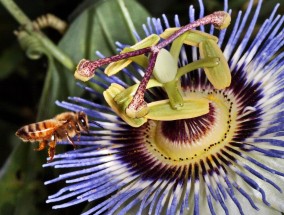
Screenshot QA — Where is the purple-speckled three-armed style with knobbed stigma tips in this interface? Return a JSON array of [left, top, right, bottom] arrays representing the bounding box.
[[75, 11, 231, 118]]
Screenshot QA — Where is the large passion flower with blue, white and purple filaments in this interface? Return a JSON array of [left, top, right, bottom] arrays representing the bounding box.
[[44, 1, 284, 215]]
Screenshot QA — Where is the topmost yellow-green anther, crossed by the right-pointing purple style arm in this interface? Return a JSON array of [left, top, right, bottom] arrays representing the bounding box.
[[159, 28, 218, 47]]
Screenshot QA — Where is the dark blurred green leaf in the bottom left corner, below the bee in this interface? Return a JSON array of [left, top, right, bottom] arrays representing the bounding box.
[[0, 141, 46, 215]]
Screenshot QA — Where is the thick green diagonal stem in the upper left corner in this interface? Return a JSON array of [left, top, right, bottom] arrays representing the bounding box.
[[0, 0, 75, 71]]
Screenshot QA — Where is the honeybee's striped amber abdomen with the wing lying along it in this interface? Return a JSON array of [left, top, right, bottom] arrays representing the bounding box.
[[16, 119, 66, 142]]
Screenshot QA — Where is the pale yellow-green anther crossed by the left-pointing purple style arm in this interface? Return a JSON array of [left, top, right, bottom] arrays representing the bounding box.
[[105, 34, 160, 76]]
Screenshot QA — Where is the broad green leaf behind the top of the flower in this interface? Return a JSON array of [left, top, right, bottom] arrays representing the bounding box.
[[59, 0, 149, 62]]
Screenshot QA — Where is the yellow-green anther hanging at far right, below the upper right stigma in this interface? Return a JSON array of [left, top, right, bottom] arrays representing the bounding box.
[[199, 40, 232, 89]]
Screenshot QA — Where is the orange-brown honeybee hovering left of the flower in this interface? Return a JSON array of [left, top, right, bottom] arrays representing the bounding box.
[[16, 111, 89, 162]]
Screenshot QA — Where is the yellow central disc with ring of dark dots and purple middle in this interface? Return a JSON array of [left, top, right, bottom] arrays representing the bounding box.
[[146, 90, 237, 164]]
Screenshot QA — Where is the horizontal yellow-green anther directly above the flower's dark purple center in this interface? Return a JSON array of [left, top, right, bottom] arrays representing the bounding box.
[[145, 98, 209, 121]]
